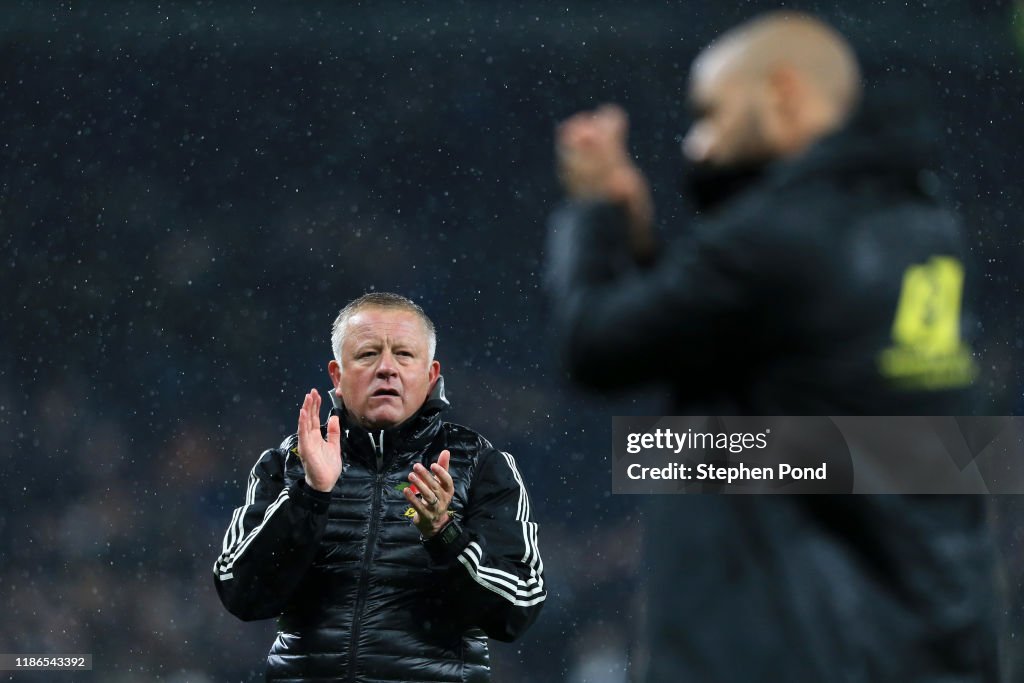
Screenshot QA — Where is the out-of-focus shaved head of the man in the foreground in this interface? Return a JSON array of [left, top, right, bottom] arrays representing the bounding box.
[[683, 12, 861, 165]]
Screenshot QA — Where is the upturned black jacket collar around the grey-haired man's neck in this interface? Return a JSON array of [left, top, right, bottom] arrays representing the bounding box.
[[328, 376, 451, 469]]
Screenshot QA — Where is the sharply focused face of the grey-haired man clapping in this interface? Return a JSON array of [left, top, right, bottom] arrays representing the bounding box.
[[328, 307, 440, 429]]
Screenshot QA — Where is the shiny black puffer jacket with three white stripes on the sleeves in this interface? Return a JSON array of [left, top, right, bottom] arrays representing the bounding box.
[[214, 379, 547, 683]]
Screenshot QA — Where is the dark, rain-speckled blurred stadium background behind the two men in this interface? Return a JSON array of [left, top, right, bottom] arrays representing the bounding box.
[[6, 0, 1024, 683]]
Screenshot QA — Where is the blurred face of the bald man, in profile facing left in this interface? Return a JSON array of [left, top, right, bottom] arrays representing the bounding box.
[[683, 48, 771, 168]]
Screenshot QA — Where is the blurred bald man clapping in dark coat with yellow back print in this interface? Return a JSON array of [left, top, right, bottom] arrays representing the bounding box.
[[547, 13, 997, 683]]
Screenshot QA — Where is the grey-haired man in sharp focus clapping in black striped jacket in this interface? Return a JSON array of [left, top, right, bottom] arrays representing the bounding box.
[[208, 293, 547, 683]]
